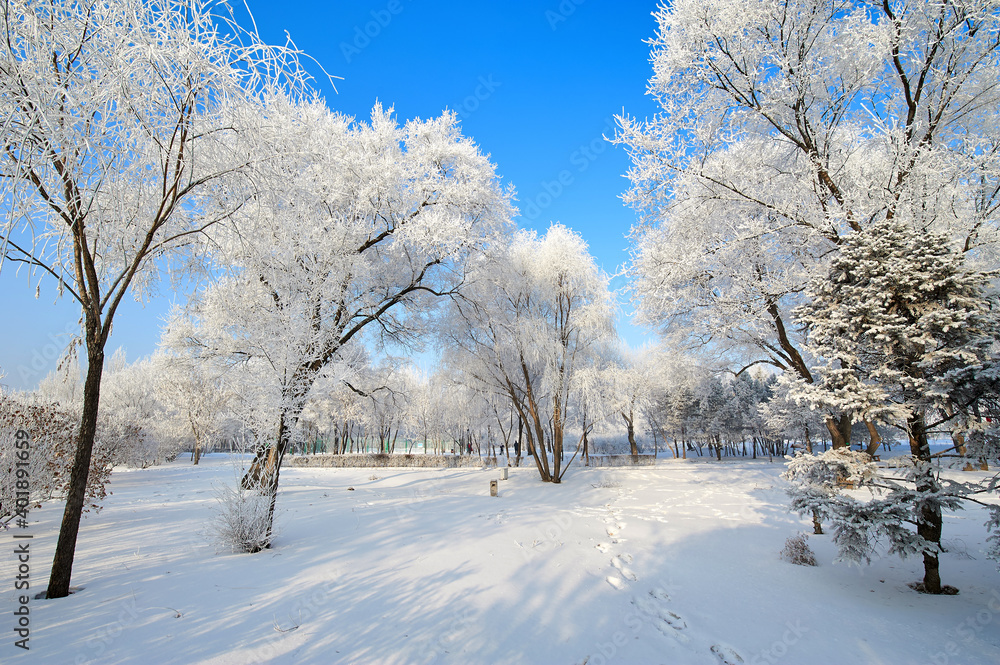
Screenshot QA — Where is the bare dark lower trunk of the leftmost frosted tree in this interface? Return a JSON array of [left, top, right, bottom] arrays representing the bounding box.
[[46, 342, 104, 598]]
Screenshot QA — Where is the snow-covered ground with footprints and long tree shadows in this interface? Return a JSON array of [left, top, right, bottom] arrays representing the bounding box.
[[0, 455, 1000, 665]]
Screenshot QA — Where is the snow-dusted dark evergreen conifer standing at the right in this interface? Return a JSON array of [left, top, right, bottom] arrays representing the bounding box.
[[791, 218, 1000, 593]]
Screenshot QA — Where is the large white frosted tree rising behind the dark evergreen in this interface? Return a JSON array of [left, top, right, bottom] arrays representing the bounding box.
[[616, 0, 1000, 446]]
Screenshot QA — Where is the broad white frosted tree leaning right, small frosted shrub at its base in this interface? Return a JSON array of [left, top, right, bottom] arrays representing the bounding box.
[[171, 101, 512, 544]]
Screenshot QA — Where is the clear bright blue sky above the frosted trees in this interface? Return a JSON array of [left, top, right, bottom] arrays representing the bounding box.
[[0, 0, 668, 388]]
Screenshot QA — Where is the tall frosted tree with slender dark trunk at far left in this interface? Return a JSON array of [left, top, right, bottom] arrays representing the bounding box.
[[0, 0, 316, 598]]
